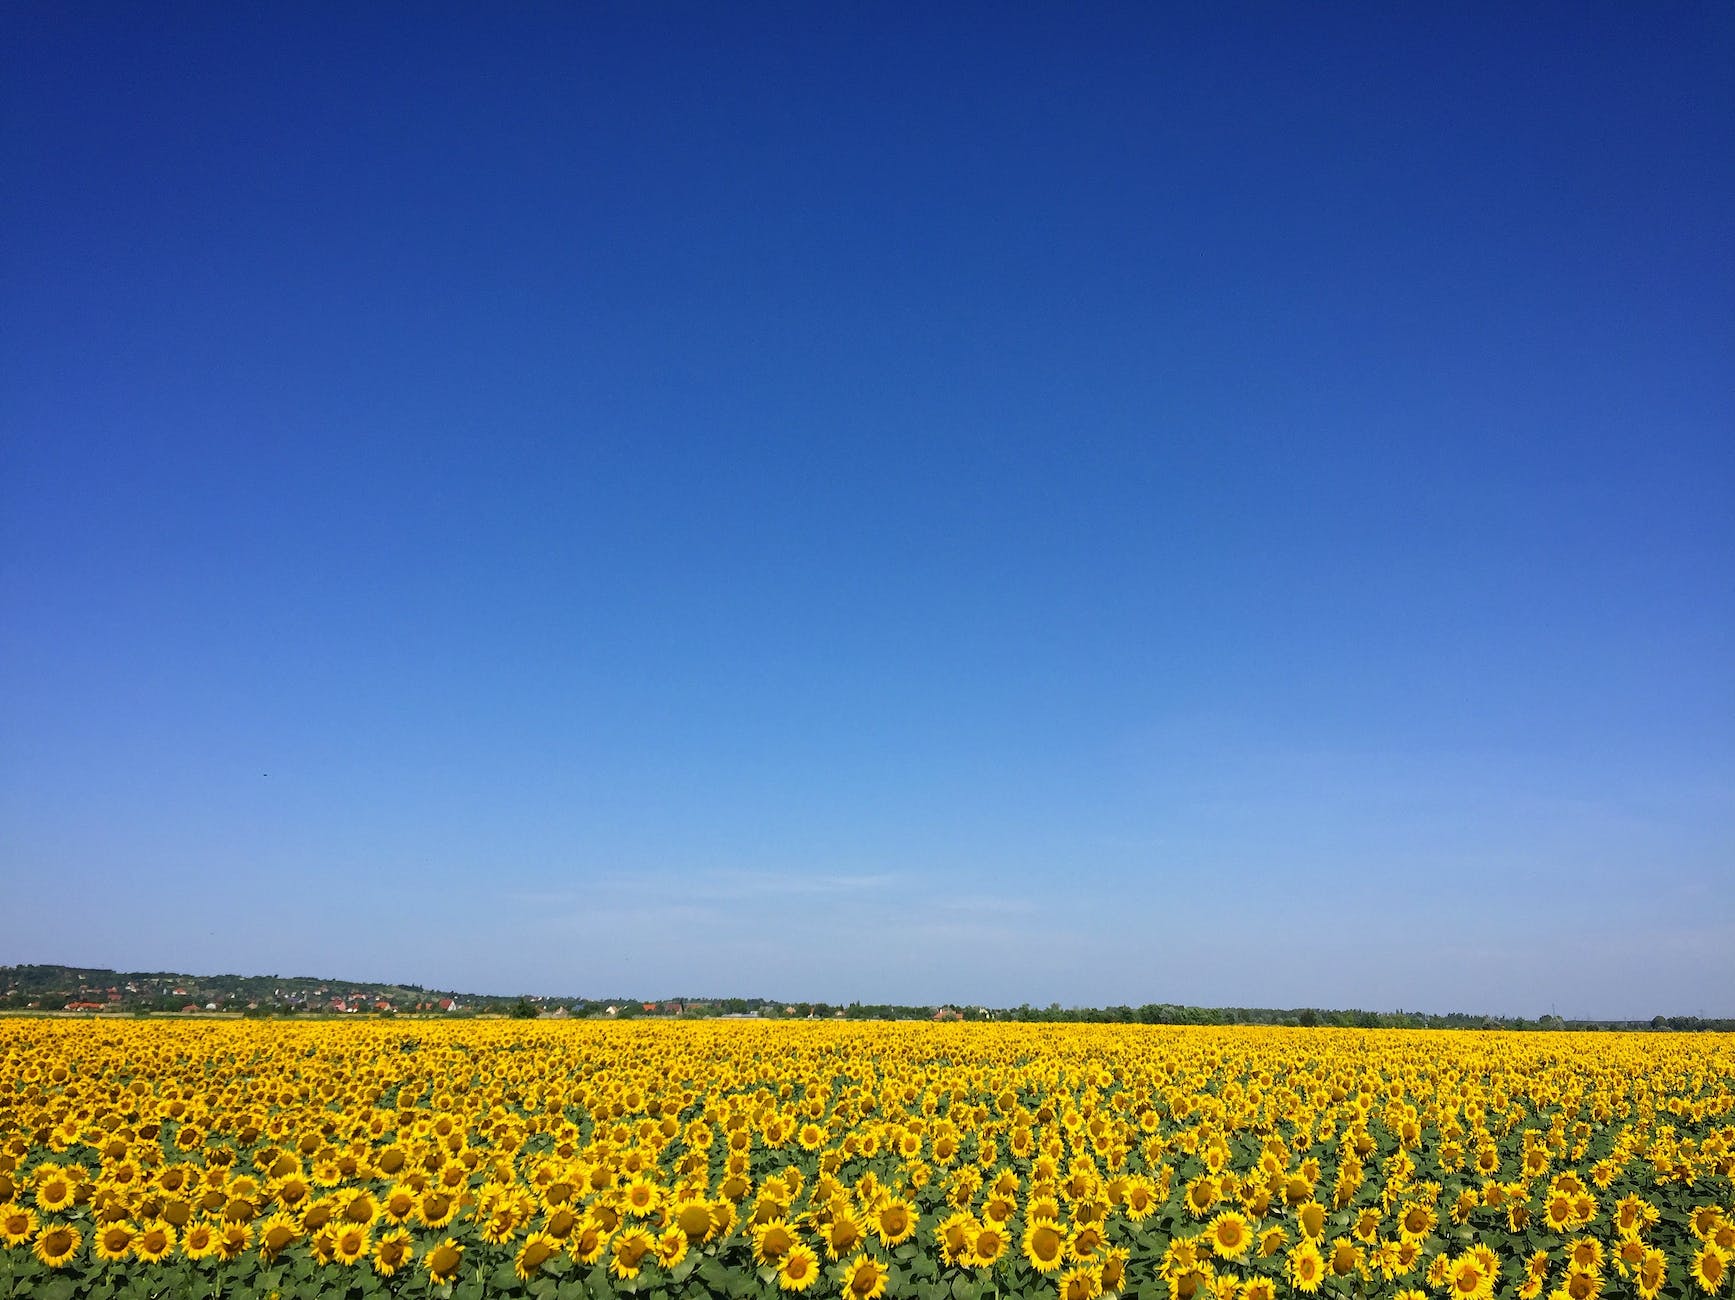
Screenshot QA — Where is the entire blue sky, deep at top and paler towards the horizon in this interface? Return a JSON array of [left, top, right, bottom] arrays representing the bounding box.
[[0, 3, 1735, 1017]]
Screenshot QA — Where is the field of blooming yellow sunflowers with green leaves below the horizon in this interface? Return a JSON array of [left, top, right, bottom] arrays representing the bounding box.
[[0, 1019, 1735, 1300]]
